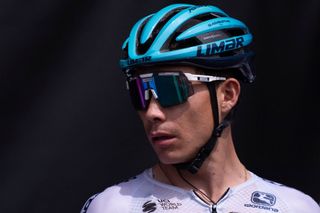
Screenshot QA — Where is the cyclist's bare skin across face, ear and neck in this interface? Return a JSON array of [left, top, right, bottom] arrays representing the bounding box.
[[138, 66, 250, 203]]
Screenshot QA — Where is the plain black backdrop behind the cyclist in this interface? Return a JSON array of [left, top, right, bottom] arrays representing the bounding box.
[[0, 0, 320, 213]]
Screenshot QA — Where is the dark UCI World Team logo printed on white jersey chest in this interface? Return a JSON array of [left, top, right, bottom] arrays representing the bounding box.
[[142, 199, 182, 213]]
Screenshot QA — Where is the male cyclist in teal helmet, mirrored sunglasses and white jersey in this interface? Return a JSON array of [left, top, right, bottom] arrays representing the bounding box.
[[82, 4, 320, 213]]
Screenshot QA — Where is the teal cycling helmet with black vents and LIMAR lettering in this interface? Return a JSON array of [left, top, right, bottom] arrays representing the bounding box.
[[120, 4, 255, 82]]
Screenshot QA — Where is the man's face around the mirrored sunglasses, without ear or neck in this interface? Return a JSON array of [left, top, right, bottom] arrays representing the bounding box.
[[138, 66, 213, 164]]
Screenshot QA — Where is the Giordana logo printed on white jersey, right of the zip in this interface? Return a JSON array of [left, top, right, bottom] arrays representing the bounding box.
[[244, 191, 279, 212]]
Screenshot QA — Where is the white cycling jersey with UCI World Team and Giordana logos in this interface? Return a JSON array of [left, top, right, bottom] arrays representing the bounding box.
[[81, 169, 320, 213]]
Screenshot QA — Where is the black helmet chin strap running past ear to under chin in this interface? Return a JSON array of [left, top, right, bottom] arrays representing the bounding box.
[[175, 83, 232, 174]]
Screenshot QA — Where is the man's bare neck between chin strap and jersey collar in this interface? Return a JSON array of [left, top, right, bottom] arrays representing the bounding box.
[[154, 128, 249, 203]]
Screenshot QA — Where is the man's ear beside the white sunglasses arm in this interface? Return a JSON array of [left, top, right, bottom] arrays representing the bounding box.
[[217, 78, 241, 113]]
